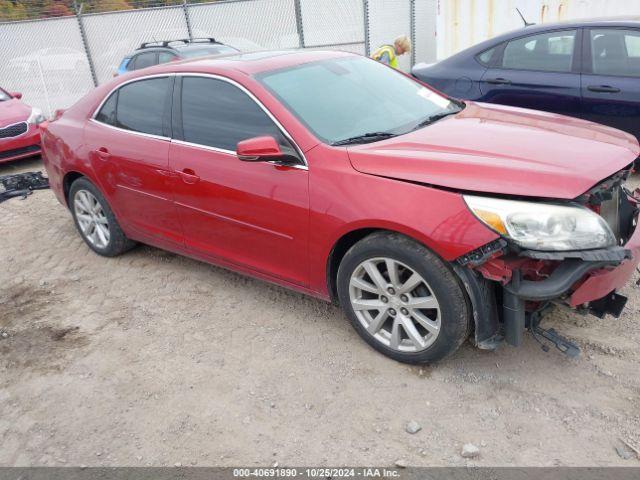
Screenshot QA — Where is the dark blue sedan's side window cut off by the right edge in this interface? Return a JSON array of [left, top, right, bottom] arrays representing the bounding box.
[[591, 28, 640, 77]]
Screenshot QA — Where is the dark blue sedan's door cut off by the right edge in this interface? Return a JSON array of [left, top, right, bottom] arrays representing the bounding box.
[[582, 27, 640, 142]]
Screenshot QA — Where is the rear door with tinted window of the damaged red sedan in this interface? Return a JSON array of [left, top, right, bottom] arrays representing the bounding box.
[[84, 76, 182, 246]]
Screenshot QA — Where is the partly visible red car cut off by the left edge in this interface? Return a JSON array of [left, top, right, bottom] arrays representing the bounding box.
[[0, 88, 46, 163]]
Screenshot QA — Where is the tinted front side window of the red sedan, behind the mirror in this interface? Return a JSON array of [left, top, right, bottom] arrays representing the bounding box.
[[182, 77, 291, 151]]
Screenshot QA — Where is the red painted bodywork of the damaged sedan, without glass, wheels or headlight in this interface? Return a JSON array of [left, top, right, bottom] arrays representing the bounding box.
[[38, 51, 639, 308]]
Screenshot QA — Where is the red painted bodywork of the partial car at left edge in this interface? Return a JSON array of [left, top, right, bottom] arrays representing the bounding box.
[[0, 92, 40, 163]]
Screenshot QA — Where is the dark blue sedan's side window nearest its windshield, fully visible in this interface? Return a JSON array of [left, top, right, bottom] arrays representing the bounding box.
[[502, 30, 576, 72]]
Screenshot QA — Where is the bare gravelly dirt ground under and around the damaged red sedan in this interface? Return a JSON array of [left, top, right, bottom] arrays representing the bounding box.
[[0, 160, 640, 466]]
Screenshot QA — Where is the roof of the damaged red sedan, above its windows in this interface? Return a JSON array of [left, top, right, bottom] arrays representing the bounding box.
[[138, 50, 360, 75]]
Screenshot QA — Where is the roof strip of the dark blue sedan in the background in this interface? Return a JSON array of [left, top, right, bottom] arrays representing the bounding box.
[[443, 16, 640, 62]]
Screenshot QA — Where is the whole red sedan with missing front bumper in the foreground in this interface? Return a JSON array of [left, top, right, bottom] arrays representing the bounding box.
[[43, 51, 640, 363]]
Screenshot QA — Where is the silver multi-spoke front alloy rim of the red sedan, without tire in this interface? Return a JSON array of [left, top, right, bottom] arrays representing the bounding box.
[[349, 257, 440, 353]]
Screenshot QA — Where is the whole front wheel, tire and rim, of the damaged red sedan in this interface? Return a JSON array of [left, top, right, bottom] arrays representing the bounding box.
[[337, 232, 471, 364]]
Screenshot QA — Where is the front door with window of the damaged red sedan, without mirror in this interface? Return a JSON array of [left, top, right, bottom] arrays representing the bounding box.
[[169, 76, 309, 285]]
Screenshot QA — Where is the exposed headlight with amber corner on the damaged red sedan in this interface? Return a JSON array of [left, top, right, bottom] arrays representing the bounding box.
[[464, 195, 616, 251]]
